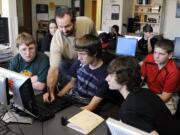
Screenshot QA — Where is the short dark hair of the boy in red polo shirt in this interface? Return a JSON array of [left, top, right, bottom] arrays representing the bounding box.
[[155, 39, 174, 53]]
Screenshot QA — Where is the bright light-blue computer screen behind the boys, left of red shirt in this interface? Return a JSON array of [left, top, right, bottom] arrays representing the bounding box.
[[116, 37, 137, 56]]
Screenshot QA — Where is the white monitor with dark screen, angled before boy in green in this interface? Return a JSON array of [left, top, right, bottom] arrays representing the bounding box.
[[0, 67, 35, 115]]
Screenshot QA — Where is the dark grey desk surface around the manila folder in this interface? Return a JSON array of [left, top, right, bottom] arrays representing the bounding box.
[[7, 106, 107, 135]]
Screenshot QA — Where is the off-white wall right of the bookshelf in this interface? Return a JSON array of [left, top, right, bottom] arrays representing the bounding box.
[[163, 0, 180, 40]]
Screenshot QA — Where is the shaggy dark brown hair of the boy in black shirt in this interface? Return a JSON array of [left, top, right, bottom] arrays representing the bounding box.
[[107, 56, 142, 91]]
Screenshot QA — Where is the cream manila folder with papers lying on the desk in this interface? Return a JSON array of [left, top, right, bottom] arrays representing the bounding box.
[[67, 109, 104, 134]]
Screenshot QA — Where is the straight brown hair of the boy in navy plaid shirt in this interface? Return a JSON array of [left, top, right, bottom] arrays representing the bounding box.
[[75, 34, 102, 58]]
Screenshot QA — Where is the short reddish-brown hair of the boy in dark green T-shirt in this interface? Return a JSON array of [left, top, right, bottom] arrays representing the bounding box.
[[16, 32, 36, 48]]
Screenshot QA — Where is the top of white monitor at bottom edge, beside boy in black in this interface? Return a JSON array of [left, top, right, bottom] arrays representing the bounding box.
[[106, 118, 150, 135]]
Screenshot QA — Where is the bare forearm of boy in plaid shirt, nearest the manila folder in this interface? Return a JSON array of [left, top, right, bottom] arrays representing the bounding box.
[[81, 96, 102, 111]]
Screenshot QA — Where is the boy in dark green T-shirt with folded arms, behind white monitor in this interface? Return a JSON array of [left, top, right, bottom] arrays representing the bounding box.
[[9, 32, 49, 94]]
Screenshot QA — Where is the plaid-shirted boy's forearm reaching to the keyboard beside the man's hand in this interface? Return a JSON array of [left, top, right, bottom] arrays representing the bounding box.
[[58, 79, 75, 97]]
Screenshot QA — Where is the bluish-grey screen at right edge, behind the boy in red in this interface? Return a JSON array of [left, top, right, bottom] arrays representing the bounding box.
[[173, 37, 180, 59]]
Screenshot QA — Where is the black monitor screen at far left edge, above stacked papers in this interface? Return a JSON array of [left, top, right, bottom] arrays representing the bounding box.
[[0, 17, 9, 44]]
